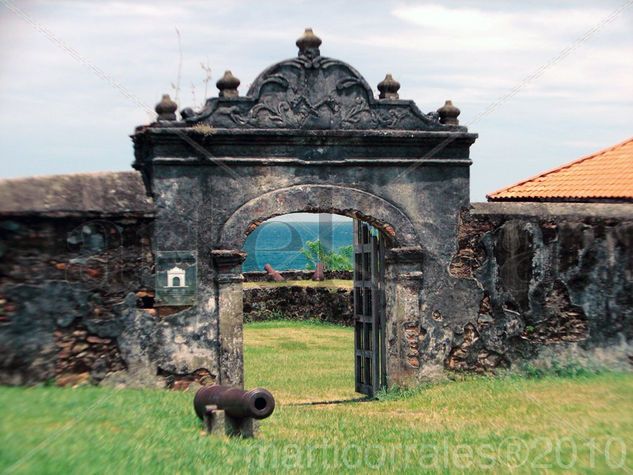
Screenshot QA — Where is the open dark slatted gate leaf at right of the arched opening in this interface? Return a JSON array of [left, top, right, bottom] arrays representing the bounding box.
[[354, 220, 386, 397]]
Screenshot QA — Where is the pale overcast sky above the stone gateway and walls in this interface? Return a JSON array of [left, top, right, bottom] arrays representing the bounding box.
[[0, 0, 633, 201]]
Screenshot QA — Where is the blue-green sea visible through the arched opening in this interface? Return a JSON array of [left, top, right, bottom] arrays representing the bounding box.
[[242, 220, 353, 272]]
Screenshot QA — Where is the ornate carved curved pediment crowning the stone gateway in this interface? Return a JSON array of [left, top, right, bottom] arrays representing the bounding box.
[[183, 30, 466, 131]]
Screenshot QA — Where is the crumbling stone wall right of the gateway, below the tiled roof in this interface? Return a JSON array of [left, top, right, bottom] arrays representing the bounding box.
[[444, 203, 633, 372]]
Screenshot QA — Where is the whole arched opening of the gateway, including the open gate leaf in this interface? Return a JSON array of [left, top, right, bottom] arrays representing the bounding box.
[[242, 213, 391, 403]]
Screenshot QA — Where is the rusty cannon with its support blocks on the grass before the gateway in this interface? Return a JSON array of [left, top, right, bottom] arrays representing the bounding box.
[[193, 385, 275, 437]]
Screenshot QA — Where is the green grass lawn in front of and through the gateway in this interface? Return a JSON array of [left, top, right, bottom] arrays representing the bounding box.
[[0, 322, 633, 474]]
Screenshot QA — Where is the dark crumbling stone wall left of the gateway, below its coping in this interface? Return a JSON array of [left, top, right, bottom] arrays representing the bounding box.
[[0, 216, 153, 384]]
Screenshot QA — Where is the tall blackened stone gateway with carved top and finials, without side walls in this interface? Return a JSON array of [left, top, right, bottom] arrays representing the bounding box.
[[133, 30, 477, 385]]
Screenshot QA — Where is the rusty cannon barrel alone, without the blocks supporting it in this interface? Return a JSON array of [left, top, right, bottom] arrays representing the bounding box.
[[193, 385, 275, 419]]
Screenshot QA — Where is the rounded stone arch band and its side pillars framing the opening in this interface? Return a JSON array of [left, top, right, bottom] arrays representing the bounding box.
[[212, 184, 423, 394]]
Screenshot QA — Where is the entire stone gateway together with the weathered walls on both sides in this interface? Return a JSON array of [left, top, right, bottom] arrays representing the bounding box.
[[0, 29, 633, 395]]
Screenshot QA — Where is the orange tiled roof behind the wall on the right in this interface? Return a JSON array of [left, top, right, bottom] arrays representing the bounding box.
[[486, 137, 633, 201]]
